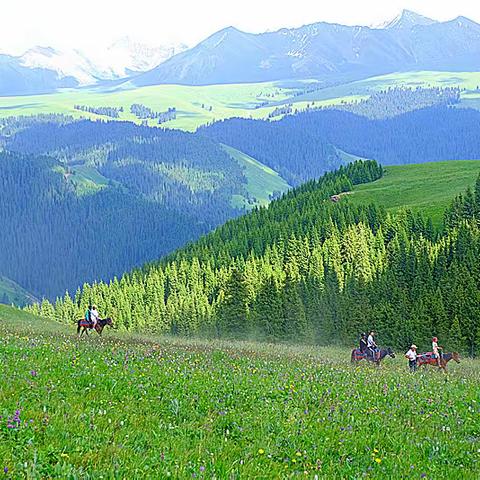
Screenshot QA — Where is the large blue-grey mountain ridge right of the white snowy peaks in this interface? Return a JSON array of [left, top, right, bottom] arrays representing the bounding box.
[[132, 10, 480, 86]]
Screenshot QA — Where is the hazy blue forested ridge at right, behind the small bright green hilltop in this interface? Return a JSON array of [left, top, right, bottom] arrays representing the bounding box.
[[199, 106, 480, 185]]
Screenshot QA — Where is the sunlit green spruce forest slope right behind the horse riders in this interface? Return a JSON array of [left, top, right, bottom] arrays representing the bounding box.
[[39, 161, 480, 354]]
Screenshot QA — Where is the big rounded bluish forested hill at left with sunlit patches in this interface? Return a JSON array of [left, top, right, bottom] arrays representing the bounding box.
[[0, 115, 263, 298]]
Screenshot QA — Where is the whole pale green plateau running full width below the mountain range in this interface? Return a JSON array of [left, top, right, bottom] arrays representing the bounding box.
[[0, 72, 480, 131]]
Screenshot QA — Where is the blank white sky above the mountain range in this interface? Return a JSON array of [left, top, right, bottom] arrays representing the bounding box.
[[0, 0, 480, 53]]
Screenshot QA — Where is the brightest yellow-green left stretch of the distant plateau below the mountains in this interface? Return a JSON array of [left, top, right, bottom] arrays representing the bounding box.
[[0, 82, 303, 131]]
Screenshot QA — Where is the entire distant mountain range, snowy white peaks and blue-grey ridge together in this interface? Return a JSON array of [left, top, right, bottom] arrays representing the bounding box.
[[0, 10, 480, 96]]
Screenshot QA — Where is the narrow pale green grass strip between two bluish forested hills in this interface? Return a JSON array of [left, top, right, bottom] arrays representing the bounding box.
[[223, 145, 290, 207]]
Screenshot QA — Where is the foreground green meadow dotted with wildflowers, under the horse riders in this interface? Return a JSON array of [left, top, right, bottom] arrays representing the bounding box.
[[0, 307, 480, 480]]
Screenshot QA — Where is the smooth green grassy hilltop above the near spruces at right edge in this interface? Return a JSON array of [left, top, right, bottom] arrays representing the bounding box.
[[348, 160, 480, 226]]
